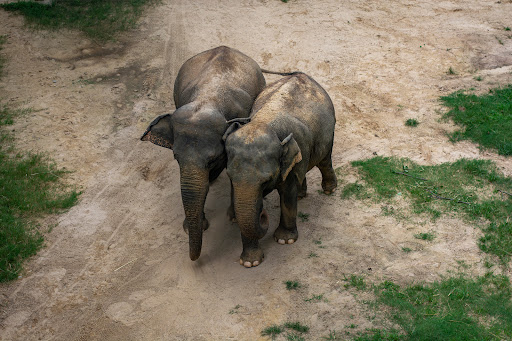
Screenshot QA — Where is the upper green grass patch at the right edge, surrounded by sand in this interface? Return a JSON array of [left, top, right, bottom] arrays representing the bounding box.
[[441, 85, 512, 155]]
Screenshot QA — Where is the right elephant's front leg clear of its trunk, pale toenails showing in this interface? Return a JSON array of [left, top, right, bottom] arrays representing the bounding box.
[[274, 176, 299, 244]]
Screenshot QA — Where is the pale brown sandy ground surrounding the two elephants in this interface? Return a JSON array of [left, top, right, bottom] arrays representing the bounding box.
[[0, 0, 512, 340]]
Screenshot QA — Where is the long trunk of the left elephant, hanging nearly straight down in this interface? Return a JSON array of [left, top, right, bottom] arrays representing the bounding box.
[[180, 167, 209, 260]]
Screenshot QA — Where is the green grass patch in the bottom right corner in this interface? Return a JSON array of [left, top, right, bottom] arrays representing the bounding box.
[[344, 273, 512, 340]]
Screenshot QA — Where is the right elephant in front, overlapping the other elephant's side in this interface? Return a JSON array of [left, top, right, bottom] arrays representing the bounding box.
[[225, 73, 337, 267]]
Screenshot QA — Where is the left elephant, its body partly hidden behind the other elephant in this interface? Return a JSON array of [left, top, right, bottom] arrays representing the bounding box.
[[141, 46, 265, 260]]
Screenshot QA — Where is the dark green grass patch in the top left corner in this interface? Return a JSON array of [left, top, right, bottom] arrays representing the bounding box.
[[0, 0, 156, 40]]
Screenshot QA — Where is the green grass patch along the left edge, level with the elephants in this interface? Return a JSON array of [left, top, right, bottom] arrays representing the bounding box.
[[0, 106, 80, 282]]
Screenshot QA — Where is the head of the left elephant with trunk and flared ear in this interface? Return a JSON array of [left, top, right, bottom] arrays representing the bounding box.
[[141, 105, 228, 260]]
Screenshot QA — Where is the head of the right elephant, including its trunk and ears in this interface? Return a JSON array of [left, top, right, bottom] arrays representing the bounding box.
[[224, 122, 302, 240]]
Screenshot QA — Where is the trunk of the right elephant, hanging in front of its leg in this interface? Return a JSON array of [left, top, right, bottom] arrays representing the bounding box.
[[233, 184, 269, 240]]
